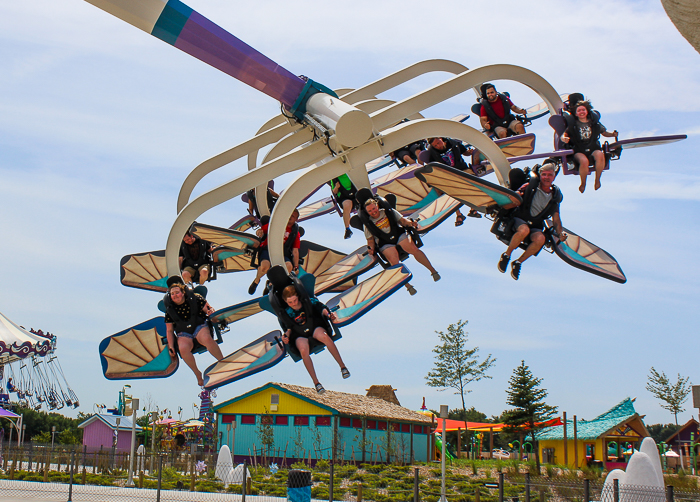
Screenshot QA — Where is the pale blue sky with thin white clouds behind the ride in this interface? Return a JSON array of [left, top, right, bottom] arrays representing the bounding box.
[[0, 0, 700, 424]]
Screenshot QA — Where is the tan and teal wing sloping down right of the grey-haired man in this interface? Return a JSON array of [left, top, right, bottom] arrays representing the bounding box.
[[546, 225, 627, 284]]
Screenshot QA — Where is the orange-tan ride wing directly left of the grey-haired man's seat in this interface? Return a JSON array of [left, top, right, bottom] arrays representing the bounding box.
[[415, 162, 522, 212]]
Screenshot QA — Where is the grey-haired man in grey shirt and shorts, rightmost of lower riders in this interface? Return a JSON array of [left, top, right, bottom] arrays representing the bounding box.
[[498, 162, 566, 281]]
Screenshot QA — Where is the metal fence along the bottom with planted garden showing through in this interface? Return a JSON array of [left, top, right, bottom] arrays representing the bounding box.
[[0, 450, 700, 502]]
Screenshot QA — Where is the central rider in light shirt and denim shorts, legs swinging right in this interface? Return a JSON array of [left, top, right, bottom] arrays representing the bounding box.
[[359, 193, 440, 282]]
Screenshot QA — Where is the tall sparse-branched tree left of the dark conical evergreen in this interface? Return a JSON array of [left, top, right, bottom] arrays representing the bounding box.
[[425, 320, 496, 410]]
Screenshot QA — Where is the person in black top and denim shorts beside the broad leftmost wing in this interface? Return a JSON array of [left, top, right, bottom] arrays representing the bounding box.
[[163, 276, 224, 386]]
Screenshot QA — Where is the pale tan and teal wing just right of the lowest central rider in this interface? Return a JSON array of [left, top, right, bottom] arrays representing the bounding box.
[[326, 263, 413, 328]]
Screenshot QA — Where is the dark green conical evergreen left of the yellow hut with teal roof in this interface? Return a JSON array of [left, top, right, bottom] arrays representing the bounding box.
[[501, 361, 557, 472]]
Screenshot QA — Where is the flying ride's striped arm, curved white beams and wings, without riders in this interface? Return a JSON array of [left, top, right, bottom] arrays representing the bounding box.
[[87, 0, 685, 389]]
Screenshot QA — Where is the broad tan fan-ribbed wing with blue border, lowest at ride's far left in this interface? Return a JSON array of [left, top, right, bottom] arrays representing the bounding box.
[[99, 317, 179, 380]]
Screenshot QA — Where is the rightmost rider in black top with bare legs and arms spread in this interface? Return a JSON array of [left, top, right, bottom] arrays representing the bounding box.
[[561, 101, 617, 193]]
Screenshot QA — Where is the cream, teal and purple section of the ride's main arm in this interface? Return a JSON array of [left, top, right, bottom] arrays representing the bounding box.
[[86, 0, 306, 108]]
